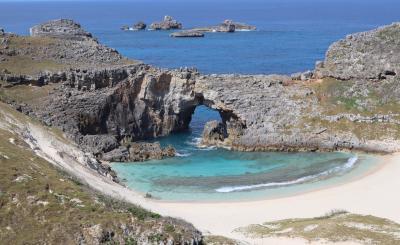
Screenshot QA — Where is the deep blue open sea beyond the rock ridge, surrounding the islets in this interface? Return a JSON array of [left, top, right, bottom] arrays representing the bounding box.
[[0, 0, 400, 74]]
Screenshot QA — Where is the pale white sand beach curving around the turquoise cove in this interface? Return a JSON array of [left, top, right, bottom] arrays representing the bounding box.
[[3, 107, 400, 244]]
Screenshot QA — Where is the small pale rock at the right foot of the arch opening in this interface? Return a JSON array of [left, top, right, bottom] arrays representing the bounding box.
[[201, 121, 228, 145]]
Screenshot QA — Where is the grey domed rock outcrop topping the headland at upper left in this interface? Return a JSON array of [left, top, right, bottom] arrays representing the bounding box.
[[30, 19, 92, 41]]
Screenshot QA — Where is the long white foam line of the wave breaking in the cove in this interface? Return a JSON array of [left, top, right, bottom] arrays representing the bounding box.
[[215, 156, 358, 193]]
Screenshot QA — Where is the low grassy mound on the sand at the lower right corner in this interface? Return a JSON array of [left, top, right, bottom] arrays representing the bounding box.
[[236, 210, 400, 245]]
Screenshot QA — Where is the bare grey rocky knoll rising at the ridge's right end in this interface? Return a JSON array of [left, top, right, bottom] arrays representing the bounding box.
[[316, 23, 400, 80]]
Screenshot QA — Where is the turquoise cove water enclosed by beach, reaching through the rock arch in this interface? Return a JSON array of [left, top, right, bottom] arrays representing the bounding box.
[[112, 106, 378, 201]]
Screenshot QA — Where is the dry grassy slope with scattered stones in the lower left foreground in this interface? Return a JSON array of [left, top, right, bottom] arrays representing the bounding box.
[[0, 103, 202, 244]]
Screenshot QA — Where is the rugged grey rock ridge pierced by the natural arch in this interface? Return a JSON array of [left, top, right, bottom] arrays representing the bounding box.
[[0, 20, 400, 177]]
